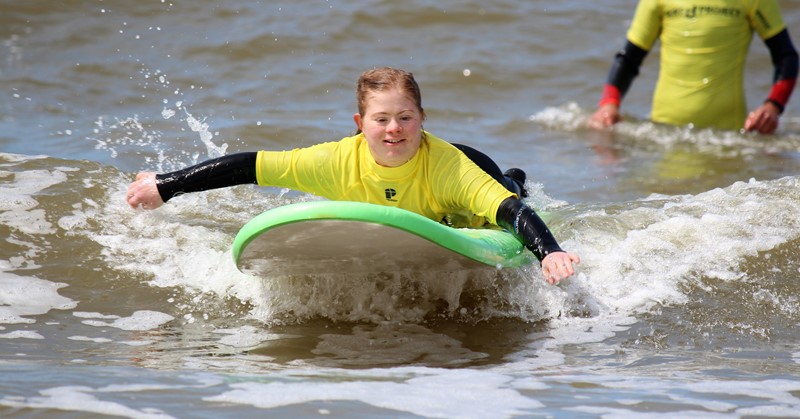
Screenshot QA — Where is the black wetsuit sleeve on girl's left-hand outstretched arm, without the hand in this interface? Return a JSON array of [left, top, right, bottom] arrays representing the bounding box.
[[156, 152, 258, 202]]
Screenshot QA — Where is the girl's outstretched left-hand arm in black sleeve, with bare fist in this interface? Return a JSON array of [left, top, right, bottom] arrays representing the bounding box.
[[127, 152, 258, 209]]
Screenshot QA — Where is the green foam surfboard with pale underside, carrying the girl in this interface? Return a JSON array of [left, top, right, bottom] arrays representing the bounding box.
[[233, 201, 535, 277]]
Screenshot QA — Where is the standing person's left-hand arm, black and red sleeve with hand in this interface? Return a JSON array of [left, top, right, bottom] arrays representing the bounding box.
[[589, 41, 647, 128]]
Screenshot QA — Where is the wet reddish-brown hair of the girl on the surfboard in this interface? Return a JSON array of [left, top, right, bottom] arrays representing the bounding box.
[[356, 67, 425, 132]]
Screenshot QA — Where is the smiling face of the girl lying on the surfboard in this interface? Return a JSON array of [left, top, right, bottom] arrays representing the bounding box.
[[353, 89, 424, 167]]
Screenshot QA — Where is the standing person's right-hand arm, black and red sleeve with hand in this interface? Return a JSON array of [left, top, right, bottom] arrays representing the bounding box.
[[744, 29, 798, 134]]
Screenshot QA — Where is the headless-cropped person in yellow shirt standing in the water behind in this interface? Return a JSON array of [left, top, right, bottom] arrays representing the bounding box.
[[588, 0, 798, 134]]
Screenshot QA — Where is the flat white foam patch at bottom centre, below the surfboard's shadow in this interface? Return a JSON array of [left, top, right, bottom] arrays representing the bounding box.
[[205, 368, 542, 418]]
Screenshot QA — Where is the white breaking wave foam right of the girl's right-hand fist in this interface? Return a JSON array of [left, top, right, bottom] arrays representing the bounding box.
[[566, 178, 800, 314]]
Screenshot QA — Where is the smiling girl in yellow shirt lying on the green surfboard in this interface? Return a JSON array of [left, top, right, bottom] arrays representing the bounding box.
[[127, 67, 580, 284]]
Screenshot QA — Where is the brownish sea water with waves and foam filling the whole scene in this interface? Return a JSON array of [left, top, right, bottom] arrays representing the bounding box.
[[0, 0, 800, 418]]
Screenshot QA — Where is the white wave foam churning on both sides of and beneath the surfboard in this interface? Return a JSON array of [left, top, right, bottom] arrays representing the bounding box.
[[78, 166, 800, 350]]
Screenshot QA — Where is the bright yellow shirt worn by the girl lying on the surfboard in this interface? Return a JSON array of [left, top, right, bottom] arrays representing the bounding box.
[[257, 132, 512, 227]]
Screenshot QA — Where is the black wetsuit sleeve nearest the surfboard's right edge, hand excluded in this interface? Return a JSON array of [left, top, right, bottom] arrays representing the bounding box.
[[497, 197, 563, 262]]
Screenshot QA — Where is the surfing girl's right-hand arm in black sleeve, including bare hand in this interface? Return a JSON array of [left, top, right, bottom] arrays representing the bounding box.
[[496, 197, 580, 284]]
